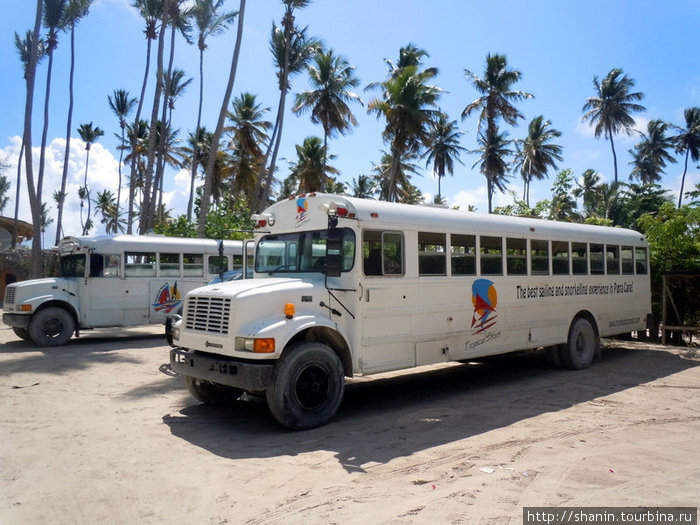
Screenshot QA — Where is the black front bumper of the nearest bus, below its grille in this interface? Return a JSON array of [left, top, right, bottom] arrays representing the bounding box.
[[170, 348, 274, 391]]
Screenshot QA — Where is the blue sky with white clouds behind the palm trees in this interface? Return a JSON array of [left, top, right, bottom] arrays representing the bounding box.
[[0, 0, 700, 243]]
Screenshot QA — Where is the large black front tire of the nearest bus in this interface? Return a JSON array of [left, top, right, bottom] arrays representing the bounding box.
[[265, 343, 345, 430]]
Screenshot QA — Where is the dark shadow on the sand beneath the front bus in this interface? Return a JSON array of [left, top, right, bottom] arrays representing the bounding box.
[[163, 347, 700, 471]]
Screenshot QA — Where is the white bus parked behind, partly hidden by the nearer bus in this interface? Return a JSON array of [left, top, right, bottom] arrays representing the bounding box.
[[3, 235, 249, 346]]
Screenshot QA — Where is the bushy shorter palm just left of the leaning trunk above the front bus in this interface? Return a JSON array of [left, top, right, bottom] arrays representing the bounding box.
[[224, 93, 272, 202]]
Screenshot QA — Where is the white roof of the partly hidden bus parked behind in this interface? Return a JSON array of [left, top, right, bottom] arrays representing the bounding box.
[[58, 234, 252, 254]]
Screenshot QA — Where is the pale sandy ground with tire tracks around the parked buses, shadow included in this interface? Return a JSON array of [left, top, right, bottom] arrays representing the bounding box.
[[0, 323, 700, 525]]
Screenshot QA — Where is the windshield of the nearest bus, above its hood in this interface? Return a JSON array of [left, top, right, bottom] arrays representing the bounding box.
[[255, 228, 355, 274]]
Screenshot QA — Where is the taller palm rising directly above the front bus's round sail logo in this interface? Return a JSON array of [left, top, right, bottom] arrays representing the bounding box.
[[462, 54, 533, 209]]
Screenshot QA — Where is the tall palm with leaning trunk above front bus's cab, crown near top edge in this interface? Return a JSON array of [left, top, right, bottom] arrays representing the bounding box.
[[258, 15, 321, 211]]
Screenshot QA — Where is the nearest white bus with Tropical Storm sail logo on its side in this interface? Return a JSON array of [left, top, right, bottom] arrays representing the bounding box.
[[171, 194, 651, 429]]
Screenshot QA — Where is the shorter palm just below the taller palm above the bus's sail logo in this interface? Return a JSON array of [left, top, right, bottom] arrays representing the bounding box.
[[470, 126, 513, 213]]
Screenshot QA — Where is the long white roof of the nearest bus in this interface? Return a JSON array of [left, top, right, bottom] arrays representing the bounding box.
[[261, 193, 646, 245]]
